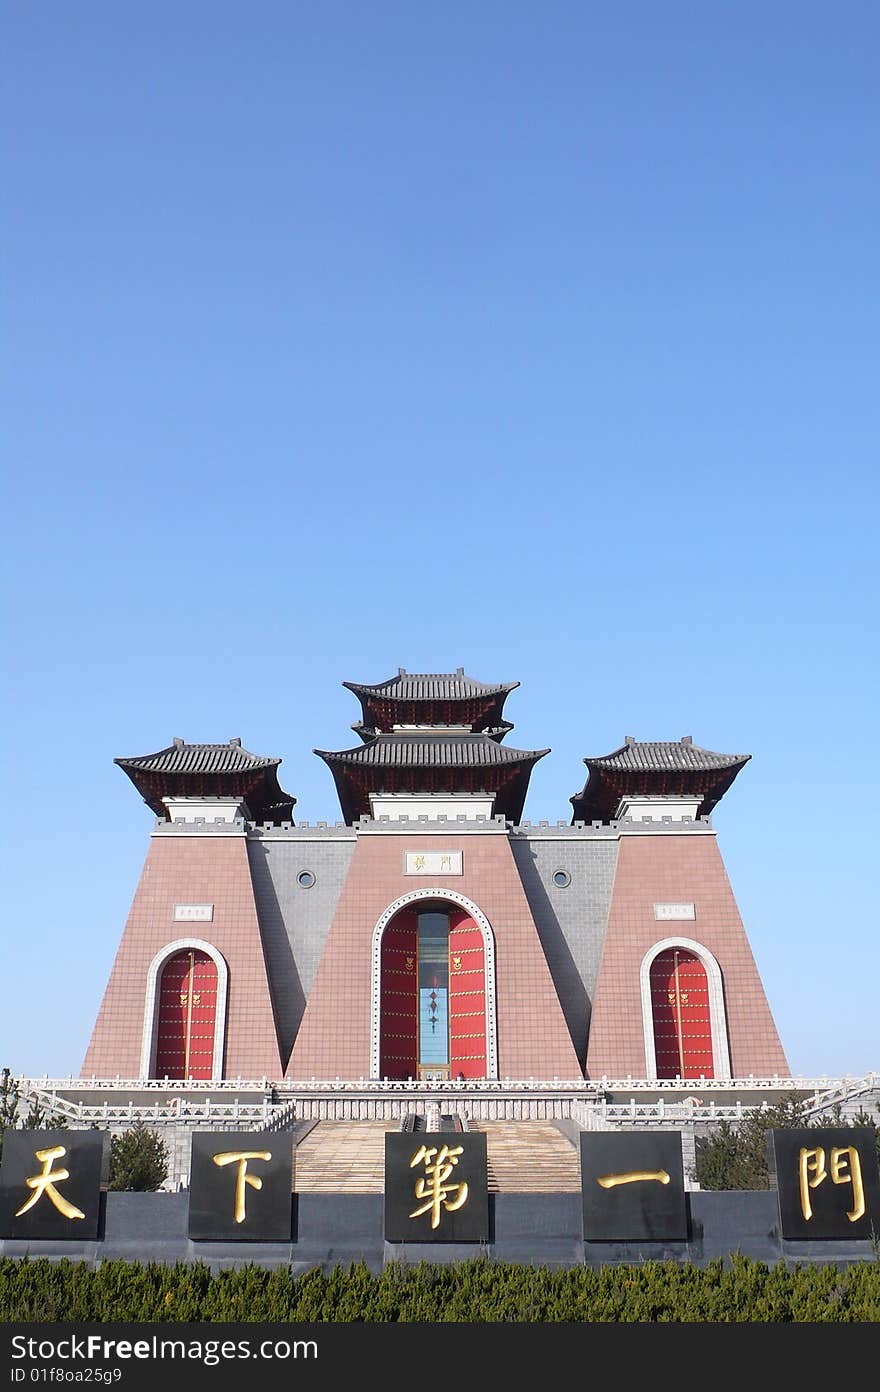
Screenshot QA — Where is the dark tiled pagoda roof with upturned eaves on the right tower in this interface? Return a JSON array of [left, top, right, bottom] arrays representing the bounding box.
[[569, 735, 752, 821]]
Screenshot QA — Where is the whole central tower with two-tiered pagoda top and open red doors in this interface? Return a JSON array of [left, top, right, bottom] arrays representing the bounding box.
[[287, 667, 581, 1082]]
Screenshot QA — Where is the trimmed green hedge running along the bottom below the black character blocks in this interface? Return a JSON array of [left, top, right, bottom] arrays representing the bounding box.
[[0, 1256, 880, 1324]]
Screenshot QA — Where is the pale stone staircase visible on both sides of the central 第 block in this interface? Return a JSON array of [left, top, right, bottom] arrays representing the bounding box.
[[294, 1121, 581, 1194]]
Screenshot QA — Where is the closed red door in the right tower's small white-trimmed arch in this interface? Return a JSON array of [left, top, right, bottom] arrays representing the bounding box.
[[650, 947, 714, 1077]]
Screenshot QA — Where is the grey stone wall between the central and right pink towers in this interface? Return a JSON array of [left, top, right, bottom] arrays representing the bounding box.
[[511, 831, 618, 1066]]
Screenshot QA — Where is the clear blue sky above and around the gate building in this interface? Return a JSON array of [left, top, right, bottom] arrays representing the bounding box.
[[0, 0, 880, 1075]]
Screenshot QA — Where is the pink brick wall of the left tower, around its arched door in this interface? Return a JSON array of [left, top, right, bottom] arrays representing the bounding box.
[[82, 835, 281, 1079]]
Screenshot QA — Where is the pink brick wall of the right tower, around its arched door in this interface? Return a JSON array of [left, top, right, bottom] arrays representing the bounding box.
[[586, 835, 788, 1077]]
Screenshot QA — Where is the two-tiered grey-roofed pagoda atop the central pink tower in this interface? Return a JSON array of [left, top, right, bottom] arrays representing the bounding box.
[[315, 667, 550, 825]]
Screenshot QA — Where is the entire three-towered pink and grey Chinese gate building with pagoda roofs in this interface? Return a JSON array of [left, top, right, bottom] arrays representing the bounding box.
[[82, 670, 788, 1083]]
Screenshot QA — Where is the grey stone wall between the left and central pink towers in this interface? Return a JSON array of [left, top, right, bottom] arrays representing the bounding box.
[[248, 827, 355, 1066]]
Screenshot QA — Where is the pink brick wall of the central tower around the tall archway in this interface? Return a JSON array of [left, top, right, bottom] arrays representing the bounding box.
[[287, 832, 581, 1079]]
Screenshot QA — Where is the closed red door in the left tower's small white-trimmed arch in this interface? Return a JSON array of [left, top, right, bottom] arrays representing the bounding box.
[[155, 948, 217, 1079]]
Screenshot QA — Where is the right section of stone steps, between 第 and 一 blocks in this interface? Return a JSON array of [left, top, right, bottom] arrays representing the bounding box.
[[469, 1121, 581, 1194]]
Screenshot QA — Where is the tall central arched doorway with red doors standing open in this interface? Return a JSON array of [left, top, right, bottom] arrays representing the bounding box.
[[379, 899, 487, 1079]]
